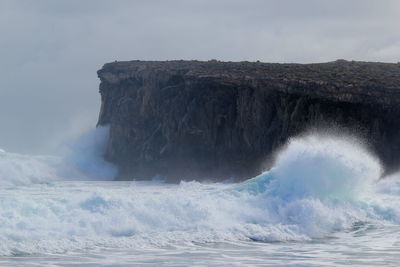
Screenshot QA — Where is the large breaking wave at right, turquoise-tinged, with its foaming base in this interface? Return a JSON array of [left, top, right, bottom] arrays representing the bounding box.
[[235, 136, 400, 241]]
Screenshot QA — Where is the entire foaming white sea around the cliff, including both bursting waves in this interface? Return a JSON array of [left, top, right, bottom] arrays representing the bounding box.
[[0, 128, 400, 266]]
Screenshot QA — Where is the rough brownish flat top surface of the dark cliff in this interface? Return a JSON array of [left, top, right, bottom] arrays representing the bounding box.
[[98, 60, 400, 105]]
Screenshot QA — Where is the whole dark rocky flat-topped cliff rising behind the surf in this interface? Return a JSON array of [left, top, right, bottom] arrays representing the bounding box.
[[98, 60, 400, 181]]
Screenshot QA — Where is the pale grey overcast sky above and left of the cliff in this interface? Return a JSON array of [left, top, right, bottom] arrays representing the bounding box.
[[0, 0, 400, 154]]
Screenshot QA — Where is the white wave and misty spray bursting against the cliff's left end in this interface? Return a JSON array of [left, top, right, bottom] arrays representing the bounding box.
[[0, 127, 117, 186]]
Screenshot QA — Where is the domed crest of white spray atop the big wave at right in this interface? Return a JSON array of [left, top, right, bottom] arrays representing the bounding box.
[[238, 135, 382, 200]]
